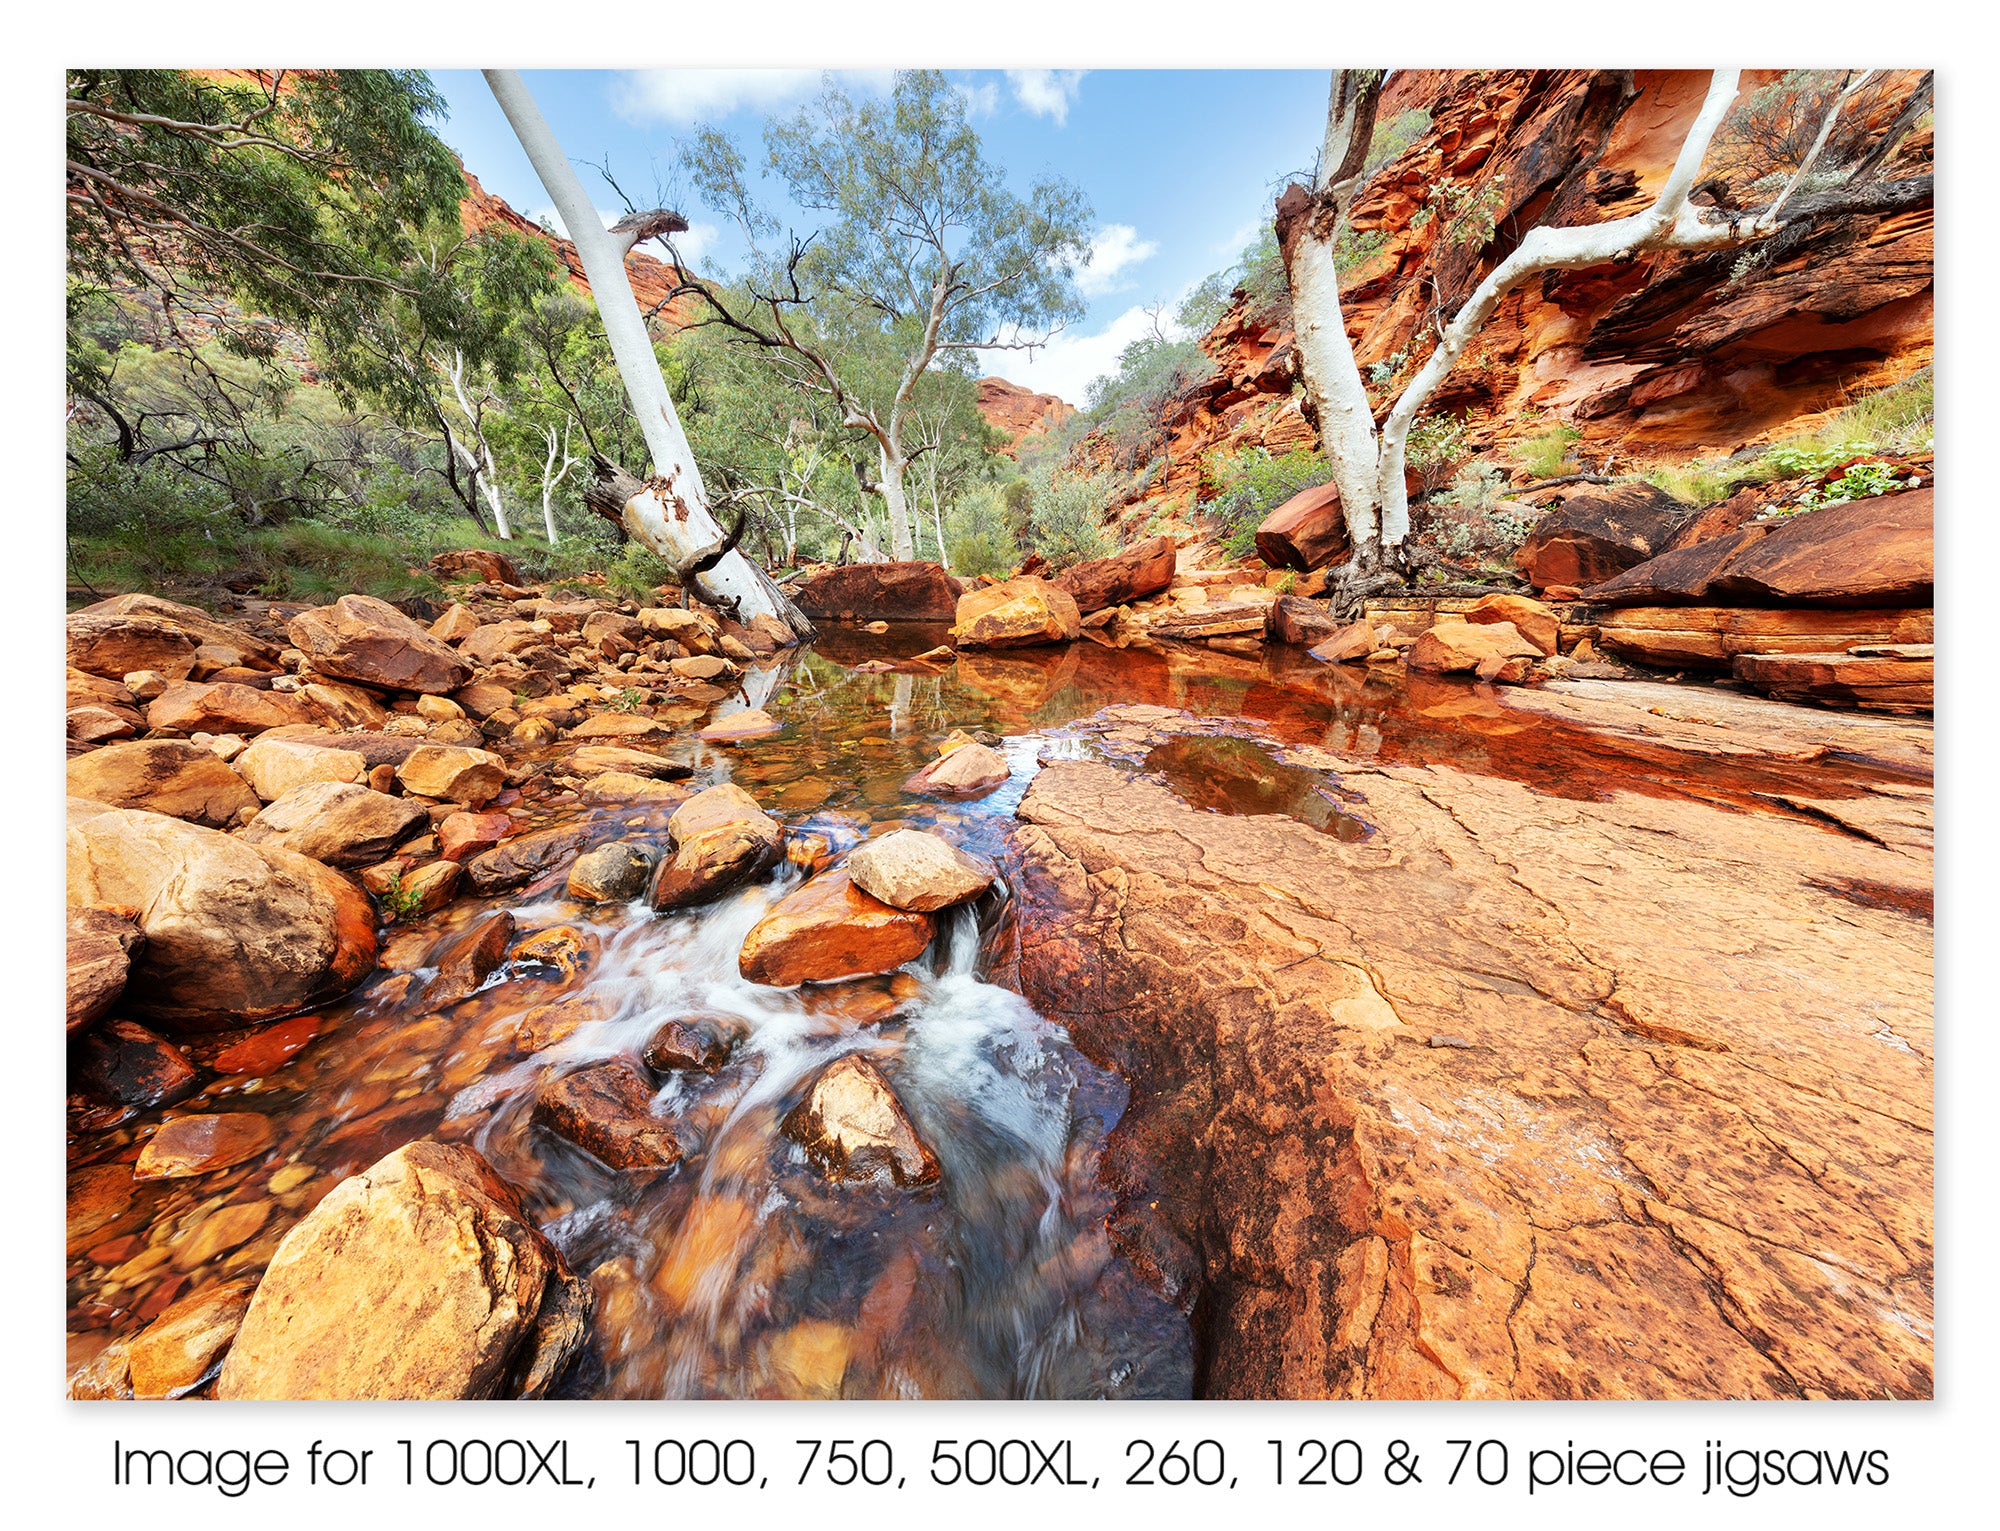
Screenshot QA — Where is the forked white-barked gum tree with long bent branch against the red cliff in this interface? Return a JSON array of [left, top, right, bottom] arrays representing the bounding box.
[[1276, 70, 1930, 606]]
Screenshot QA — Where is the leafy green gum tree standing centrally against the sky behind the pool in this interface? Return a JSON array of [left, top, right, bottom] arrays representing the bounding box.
[[684, 70, 1090, 560]]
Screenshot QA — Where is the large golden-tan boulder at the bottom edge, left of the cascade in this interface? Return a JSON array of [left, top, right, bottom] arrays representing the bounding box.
[[216, 1141, 590, 1399]]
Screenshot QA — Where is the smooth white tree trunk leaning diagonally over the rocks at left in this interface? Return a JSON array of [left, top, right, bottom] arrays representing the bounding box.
[[484, 70, 814, 638]]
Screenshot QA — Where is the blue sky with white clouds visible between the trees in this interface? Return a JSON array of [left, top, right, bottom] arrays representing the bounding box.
[[432, 70, 1326, 404]]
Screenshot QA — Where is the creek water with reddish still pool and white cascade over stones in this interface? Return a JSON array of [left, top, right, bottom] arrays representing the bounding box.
[[68, 628, 1928, 1397]]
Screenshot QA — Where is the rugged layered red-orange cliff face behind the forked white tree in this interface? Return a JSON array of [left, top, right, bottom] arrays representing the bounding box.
[[1104, 70, 1932, 504]]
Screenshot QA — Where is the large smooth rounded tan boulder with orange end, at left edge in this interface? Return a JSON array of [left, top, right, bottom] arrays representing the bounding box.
[[68, 797, 376, 1031]]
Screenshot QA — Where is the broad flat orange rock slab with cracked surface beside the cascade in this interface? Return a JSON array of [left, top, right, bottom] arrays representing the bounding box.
[[1010, 708, 1932, 1399]]
